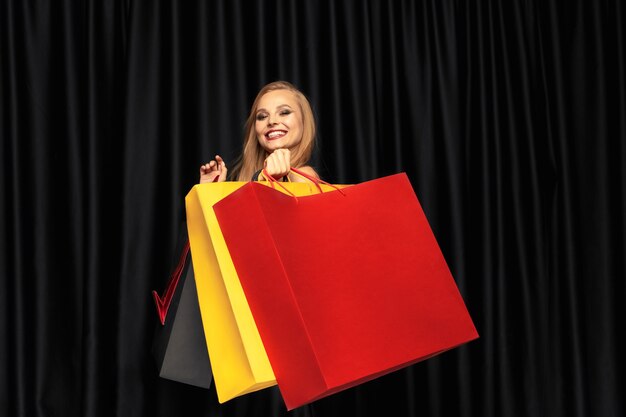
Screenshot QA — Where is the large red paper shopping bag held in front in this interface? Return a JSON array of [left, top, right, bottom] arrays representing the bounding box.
[[214, 174, 478, 409]]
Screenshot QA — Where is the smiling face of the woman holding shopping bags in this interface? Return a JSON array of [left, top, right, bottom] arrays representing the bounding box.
[[255, 90, 303, 153]]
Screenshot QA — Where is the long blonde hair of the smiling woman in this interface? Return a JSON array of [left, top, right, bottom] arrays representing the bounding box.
[[232, 81, 315, 181]]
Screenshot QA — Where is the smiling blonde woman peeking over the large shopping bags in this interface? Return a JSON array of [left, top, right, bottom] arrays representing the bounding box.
[[200, 81, 319, 184]]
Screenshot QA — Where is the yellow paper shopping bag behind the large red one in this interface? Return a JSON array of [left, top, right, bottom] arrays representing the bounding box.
[[186, 182, 342, 403]]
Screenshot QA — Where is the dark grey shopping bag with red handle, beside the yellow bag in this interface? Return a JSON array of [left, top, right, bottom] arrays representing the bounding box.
[[152, 225, 212, 388]]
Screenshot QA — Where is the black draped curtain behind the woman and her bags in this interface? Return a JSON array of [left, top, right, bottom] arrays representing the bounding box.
[[0, 0, 626, 417]]
